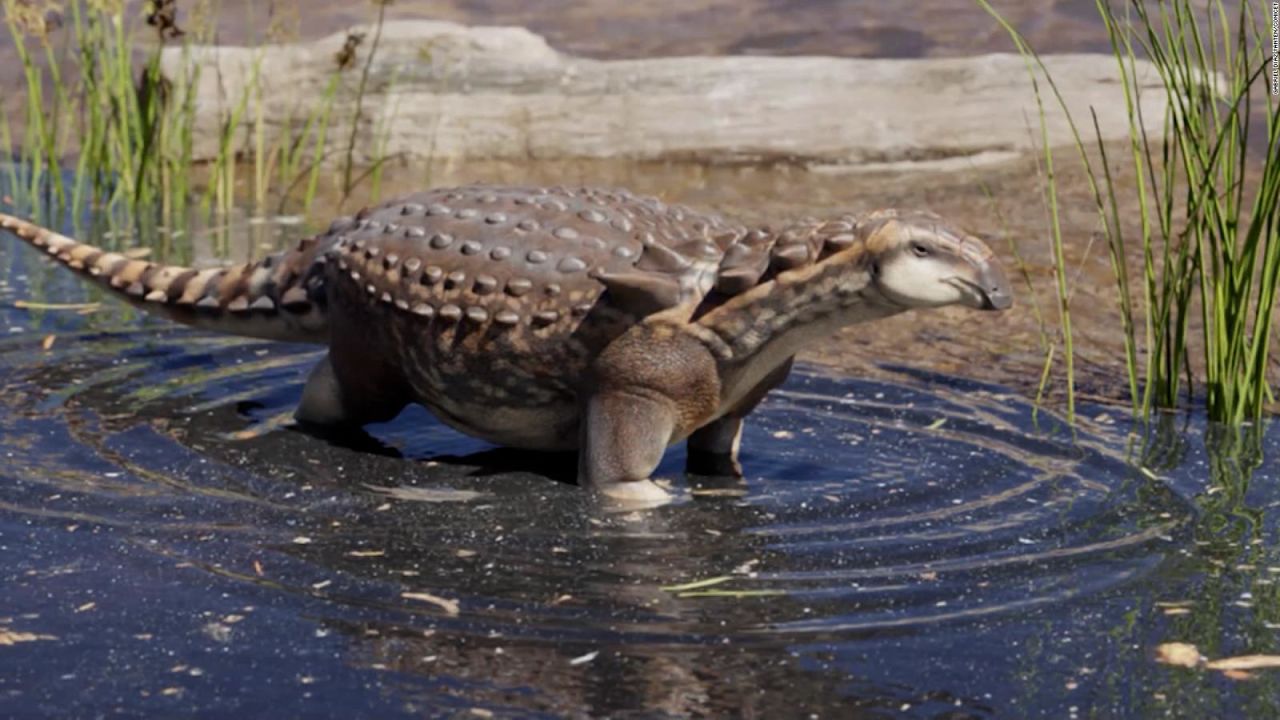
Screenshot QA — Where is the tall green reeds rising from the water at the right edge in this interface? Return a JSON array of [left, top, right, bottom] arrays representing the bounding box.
[[977, 0, 1280, 423]]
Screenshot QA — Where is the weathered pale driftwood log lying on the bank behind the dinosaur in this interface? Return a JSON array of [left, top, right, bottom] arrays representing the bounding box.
[[154, 20, 1165, 168]]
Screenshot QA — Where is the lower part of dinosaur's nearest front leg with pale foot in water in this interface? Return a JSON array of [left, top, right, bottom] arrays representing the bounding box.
[[577, 391, 677, 502]]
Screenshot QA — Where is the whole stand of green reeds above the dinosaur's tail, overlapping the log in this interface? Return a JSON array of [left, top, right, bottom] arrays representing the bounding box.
[[0, 0, 399, 227]]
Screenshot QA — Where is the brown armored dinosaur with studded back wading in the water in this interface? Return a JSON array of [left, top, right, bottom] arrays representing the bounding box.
[[0, 186, 1012, 501]]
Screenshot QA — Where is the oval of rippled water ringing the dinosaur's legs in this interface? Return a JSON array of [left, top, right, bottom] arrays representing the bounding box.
[[0, 322, 1189, 644]]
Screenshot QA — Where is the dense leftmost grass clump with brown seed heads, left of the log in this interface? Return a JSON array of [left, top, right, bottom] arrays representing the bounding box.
[[4, 0, 204, 215]]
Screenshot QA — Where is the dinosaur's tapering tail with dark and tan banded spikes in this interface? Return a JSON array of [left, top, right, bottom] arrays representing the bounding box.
[[0, 213, 329, 343]]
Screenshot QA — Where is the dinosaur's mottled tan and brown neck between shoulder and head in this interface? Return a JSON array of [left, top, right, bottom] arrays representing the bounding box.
[[695, 237, 905, 395]]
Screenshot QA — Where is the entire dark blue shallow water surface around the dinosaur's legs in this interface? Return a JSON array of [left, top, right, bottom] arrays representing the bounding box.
[[0, 213, 1280, 719]]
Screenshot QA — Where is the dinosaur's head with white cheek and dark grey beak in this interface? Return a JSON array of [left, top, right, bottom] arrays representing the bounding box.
[[855, 210, 1014, 310]]
